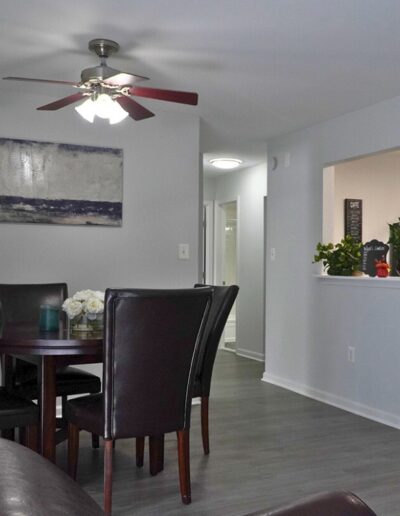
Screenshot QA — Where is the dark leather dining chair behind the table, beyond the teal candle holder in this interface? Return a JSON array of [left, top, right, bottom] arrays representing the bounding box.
[[0, 283, 101, 447]]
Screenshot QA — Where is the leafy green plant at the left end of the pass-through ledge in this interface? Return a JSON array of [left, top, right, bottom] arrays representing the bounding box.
[[313, 235, 362, 276]]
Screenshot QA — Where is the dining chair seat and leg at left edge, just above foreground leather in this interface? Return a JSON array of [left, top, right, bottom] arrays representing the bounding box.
[[0, 387, 39, 451]]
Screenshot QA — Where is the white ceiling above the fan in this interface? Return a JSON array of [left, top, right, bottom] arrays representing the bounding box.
[[0, 0, 400, 177]]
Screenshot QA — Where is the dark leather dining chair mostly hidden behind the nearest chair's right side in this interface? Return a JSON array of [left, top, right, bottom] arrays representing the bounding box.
[[140, 283, 239, 475]]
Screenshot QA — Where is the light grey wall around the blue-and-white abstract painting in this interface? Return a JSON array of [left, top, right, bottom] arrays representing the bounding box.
[[0, 87, 200, 374]]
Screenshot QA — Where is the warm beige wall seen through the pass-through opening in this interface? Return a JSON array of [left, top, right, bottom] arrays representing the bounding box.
[[333, 151, 400, 242]]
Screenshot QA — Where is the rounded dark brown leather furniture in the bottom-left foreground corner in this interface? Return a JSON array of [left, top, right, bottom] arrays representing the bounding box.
[[0, 439, 104, 516]]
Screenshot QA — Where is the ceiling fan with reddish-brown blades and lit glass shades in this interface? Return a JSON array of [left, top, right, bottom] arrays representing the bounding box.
[[3, 38, 198, 124]]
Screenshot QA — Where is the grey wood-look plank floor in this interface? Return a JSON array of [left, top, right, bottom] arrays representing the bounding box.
[[57, 351, 400, 516]]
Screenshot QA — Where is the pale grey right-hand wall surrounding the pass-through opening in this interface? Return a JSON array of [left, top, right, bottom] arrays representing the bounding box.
[[264, 94, 400, 427]]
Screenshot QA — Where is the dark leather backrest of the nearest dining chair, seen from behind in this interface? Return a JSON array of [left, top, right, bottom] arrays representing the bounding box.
[[103, 288, 213, 439]]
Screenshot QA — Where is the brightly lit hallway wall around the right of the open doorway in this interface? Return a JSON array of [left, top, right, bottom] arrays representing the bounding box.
[[204, 164, 267, 359]]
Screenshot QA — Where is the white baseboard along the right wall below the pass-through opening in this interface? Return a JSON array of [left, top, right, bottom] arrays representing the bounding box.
[[262, 372, 400, 429]]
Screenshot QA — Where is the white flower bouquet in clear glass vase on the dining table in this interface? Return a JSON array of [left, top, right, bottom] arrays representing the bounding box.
[[62, 289, 104, 331]]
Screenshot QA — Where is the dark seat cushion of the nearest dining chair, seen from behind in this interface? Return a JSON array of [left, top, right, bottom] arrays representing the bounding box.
[[65, 393, 104, 435]]
